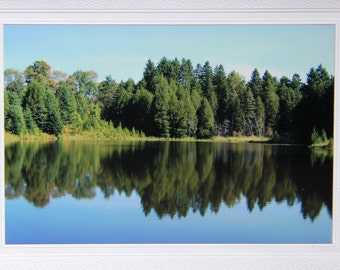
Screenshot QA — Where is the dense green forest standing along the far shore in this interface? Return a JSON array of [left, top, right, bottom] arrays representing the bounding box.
[[4, 57, 334, 144]]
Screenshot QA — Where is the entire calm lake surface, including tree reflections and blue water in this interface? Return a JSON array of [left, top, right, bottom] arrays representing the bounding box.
[[5, 142, 332, 244]]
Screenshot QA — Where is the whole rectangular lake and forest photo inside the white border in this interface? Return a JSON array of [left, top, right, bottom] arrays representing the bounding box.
[[3, 24, 335, 245]]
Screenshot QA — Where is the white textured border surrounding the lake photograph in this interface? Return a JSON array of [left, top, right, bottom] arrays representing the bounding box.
[[0, 0, 340, 270]]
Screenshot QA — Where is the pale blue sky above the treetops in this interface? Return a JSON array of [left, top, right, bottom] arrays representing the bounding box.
[[4, 25, 335, 82]]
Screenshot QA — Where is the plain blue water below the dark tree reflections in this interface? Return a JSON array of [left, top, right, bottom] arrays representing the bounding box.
[[6, 190, 332, 244]]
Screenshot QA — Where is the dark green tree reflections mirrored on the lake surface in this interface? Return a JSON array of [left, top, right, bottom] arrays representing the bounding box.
[[5, 139, 333, 221]]
